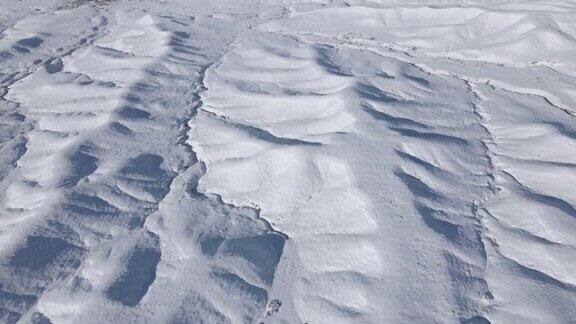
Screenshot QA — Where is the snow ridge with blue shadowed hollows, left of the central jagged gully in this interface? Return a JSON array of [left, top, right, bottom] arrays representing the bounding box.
[[0, 1, 284, 322]]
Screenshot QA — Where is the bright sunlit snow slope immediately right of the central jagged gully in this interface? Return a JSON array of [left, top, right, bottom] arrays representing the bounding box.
[[190, 36, 382, 321]]
